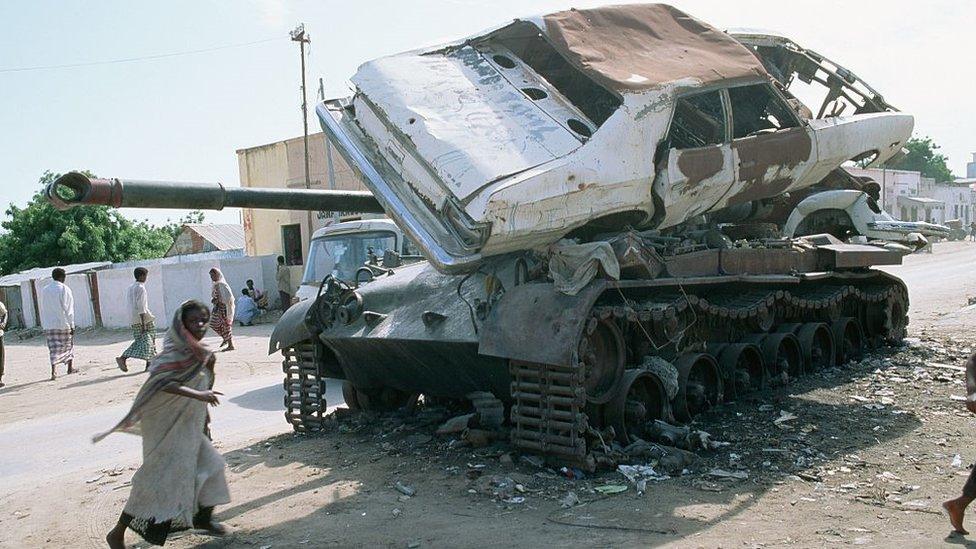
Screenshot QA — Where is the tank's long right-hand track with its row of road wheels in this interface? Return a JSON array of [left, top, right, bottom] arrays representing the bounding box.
[[510, 275, 908, 469]]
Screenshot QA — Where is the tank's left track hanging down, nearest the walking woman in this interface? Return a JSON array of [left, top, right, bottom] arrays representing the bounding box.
[[281, 341, 327, 433]]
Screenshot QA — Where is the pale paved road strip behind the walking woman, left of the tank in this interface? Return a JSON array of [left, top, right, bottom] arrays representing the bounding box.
[[0, 374, 344, 493]]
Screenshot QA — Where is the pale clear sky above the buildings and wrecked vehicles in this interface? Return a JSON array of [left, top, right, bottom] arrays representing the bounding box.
[[0, 0, 976, 227]]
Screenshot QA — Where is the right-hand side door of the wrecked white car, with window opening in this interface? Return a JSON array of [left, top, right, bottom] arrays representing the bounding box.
[[719, 83, 817, 206]]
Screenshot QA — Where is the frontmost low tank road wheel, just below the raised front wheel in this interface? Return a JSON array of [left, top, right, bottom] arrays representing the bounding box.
[[604, 369, 671, 444]]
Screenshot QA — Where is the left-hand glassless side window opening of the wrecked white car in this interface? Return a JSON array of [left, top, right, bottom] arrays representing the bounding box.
[[668, 90, 726, 149]]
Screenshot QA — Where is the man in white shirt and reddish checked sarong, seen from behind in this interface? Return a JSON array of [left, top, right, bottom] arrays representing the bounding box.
[[41, 267, 77, 381]]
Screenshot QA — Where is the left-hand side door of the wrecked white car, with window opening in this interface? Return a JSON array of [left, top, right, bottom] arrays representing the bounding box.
[[654, 90, 735, 228]]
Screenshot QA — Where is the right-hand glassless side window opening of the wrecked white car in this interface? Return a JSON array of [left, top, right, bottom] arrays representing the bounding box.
[[729, 84, 800, 139]]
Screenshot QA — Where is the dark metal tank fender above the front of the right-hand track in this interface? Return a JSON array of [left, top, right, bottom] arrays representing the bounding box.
[[478, 280, 607, 366]]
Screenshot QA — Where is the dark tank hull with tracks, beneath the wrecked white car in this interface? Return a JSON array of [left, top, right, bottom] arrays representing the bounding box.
[[275, 235, 908, 467]]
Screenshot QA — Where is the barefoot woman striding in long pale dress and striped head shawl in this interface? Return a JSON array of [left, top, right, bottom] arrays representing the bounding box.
[[93, 301, 230, 549]]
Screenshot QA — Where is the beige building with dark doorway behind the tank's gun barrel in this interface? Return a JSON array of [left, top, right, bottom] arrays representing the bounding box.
[[237, 133, 366, 268]]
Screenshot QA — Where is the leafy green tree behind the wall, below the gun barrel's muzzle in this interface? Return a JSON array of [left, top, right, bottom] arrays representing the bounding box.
[[0, 171, 179, 274]]
